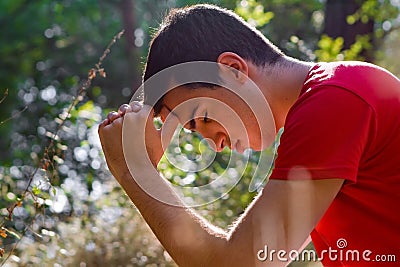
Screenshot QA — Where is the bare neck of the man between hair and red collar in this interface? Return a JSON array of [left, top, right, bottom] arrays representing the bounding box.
[[249, 57, 313, 131]]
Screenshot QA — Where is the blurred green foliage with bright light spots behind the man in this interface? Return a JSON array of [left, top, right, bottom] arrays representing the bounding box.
[[0, 0, 400, 266]]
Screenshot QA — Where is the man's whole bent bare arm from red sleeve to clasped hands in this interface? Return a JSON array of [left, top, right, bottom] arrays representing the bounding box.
[[99, 105, 343, 266]]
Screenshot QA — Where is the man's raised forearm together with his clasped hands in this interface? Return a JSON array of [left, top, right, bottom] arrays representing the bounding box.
[[99, 110, 239, 266]]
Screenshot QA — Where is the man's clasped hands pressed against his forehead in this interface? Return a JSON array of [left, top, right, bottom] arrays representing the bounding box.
[[98, 102, 176, 182]]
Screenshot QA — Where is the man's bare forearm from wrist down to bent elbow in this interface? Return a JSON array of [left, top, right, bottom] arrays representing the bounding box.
[[118, 172, 228, 266]]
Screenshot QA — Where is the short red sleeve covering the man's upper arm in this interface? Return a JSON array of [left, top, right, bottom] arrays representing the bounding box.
[[270, 86, 374, 182]]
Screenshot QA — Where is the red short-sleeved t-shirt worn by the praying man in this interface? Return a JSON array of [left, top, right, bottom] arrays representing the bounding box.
[[270, 62, 400, 266]]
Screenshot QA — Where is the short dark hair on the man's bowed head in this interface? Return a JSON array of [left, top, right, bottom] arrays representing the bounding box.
[[143, 4, 283, 114]]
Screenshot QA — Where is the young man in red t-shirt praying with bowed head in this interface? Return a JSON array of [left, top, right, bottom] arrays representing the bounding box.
[[99, 5, 400, 266]]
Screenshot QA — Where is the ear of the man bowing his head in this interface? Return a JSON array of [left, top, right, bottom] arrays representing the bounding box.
[[217, 52, 249, 83]]
